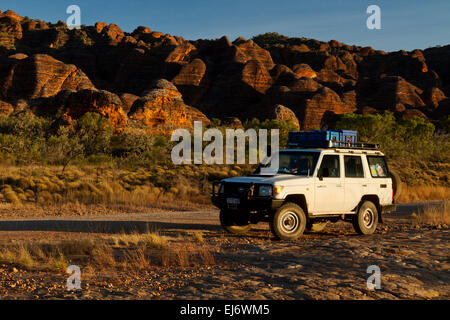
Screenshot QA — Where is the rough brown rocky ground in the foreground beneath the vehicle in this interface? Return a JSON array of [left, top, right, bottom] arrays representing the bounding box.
[[0, 208, 450, 299]]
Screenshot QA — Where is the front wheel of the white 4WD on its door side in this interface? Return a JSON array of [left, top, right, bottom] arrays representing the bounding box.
[[270, 203, 306, 240]]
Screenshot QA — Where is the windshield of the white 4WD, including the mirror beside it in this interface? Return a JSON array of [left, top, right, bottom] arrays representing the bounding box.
[[255, 151, 320, 176]]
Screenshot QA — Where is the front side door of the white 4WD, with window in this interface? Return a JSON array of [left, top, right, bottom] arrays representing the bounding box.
[[314, 155, 344, 213]]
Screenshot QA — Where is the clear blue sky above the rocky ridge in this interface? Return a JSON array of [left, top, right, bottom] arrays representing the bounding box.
[[0, 0, 450, 51]]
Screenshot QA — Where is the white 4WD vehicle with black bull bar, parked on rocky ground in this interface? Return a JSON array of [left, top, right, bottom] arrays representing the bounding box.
[[212, 147, 399, 240]]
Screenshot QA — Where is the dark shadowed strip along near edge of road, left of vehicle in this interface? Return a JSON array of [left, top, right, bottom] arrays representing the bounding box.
[[0, 220, 222, 234]]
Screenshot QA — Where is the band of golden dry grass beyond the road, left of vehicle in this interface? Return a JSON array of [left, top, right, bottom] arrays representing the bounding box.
[[0, 165, 253, 207]]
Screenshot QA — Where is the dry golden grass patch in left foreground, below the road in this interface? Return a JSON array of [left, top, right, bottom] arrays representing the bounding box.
[[0, 232, 215, 272]]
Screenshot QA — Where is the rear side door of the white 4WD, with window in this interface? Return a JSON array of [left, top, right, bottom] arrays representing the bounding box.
[[344, 155, 368, 212]]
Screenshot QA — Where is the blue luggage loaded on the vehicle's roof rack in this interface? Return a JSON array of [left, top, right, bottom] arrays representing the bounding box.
[[286, 130, 379, 149]]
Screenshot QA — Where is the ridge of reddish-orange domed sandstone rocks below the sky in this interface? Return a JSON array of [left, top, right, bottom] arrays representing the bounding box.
[[0, 11, 450, 130]]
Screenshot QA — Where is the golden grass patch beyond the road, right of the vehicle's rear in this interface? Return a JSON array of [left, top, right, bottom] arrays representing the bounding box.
[[398, 185, 450, 203]]
